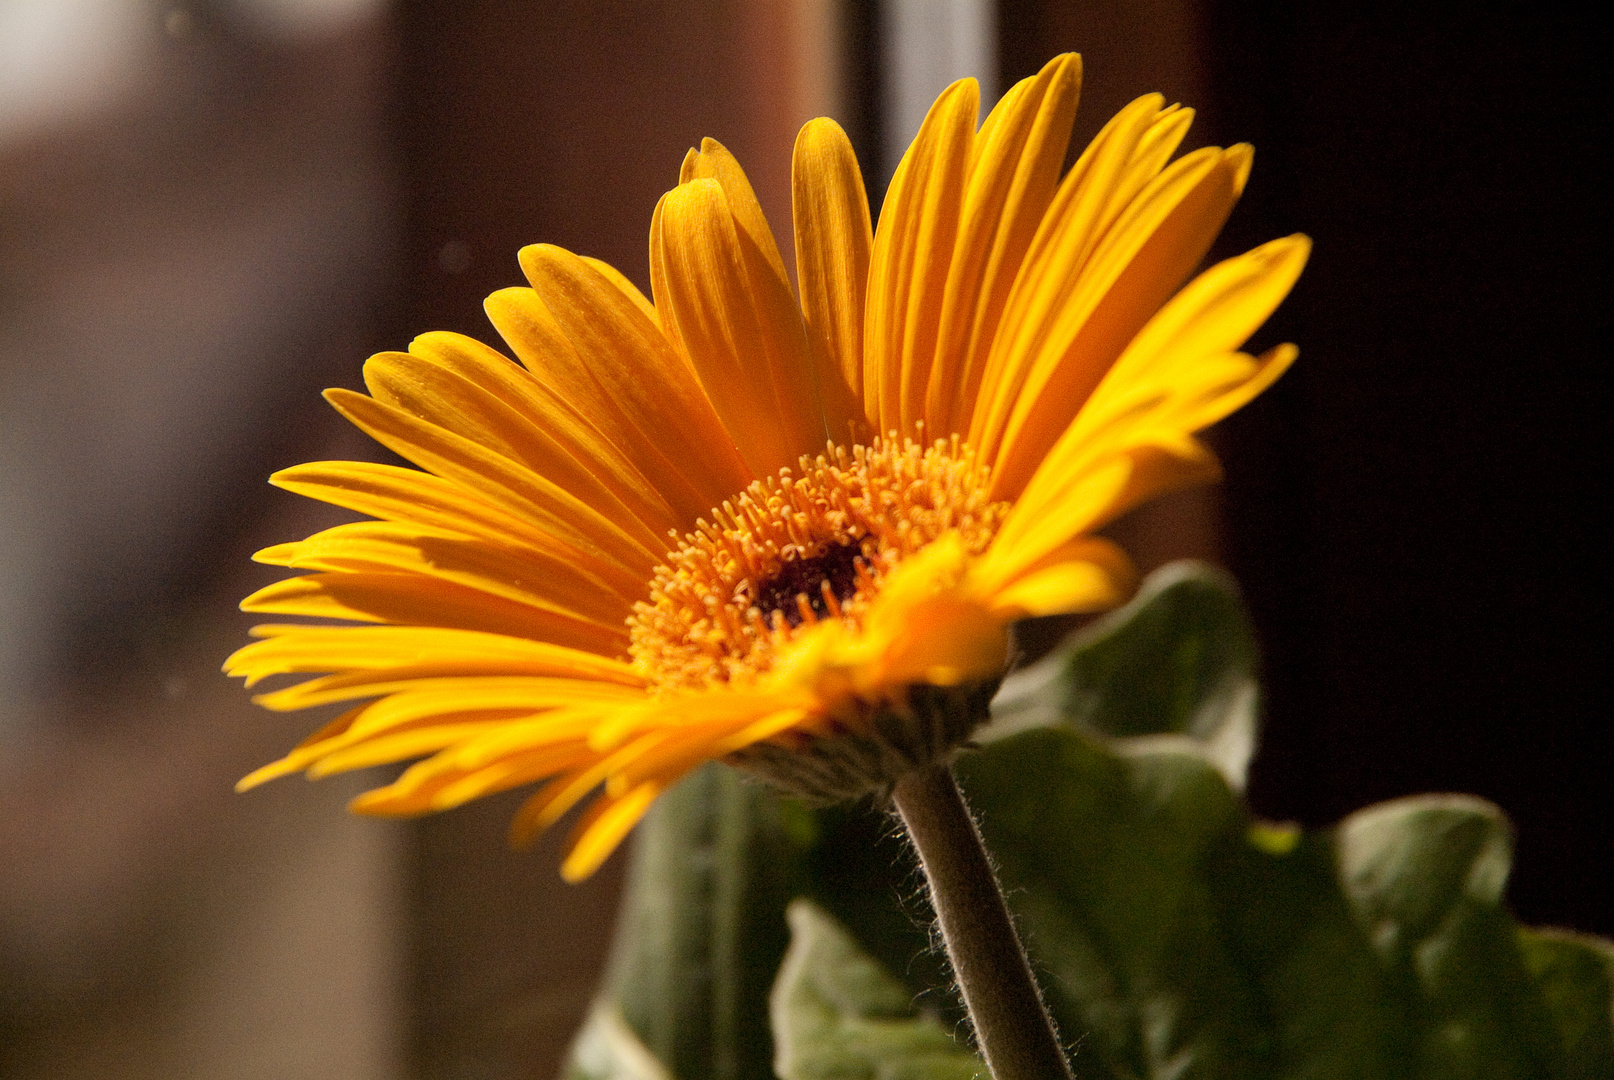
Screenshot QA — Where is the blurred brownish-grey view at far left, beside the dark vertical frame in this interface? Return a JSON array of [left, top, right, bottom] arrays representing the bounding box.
[[0, 0, 404, 1080]]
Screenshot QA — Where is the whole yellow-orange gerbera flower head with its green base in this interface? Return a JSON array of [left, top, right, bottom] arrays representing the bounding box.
[[226, 55, 1309, 880]]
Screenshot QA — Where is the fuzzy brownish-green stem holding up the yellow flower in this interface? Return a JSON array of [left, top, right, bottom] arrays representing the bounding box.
[[891, 765, 1072, 1080]]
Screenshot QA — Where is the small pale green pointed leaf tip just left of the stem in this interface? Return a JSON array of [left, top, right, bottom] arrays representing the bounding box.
[[771, 901, 986, 1080]]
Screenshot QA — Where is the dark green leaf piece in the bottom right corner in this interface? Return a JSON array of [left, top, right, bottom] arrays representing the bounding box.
[[1519, 930, 1614, 1080]]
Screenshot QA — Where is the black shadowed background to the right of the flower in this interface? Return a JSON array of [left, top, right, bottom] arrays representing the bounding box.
[[1002, 0, 1614, 933]]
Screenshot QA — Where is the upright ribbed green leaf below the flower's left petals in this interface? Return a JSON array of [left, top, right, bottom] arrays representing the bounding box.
[[573, 764, 812, 1080]]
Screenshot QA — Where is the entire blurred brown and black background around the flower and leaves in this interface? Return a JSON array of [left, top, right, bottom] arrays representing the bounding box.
[[0, 0, 1614, 1080]]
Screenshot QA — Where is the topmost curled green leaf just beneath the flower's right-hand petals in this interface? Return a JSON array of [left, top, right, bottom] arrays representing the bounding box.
[[983, 562, 1259, 789]]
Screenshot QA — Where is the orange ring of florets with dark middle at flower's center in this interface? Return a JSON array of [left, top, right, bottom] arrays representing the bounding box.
[[628, 437, 1009, 688]]
